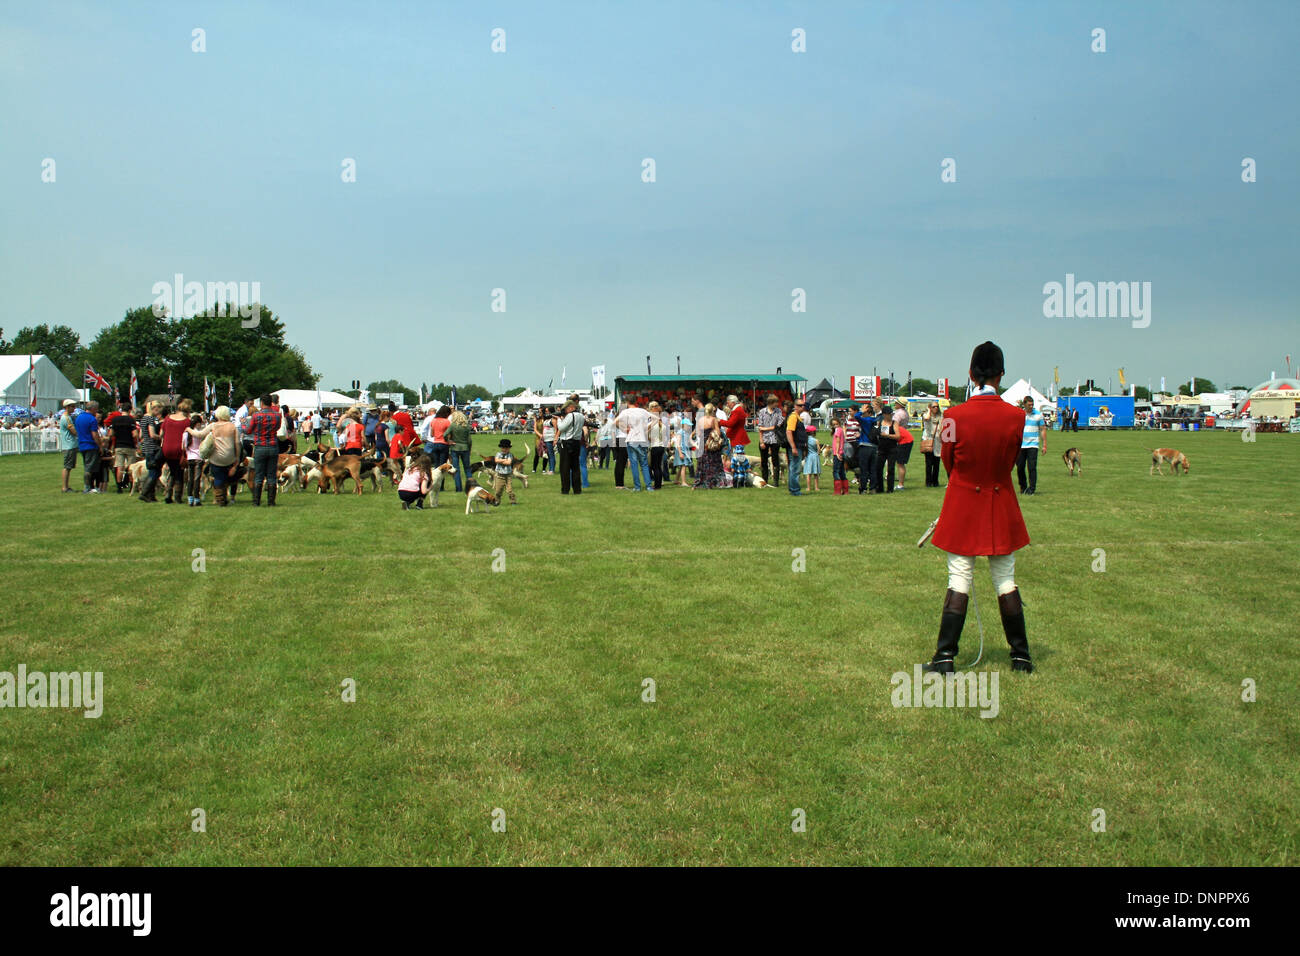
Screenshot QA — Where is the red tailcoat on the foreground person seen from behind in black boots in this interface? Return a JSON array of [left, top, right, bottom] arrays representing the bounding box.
[[932, 395, 1030, 554]]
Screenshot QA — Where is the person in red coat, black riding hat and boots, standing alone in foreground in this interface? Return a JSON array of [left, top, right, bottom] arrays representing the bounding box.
[[926, 342, 1034, 674]]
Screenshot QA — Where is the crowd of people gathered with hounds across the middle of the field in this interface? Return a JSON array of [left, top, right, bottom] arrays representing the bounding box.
[[43, 382, 1066, 507]]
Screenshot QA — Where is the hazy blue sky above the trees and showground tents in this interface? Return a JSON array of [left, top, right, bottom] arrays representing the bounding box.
[[0, 0, 1300, 386]]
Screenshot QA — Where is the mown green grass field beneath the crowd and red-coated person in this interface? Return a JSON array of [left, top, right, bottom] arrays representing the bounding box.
[[0, 432, 1300, 866]]
